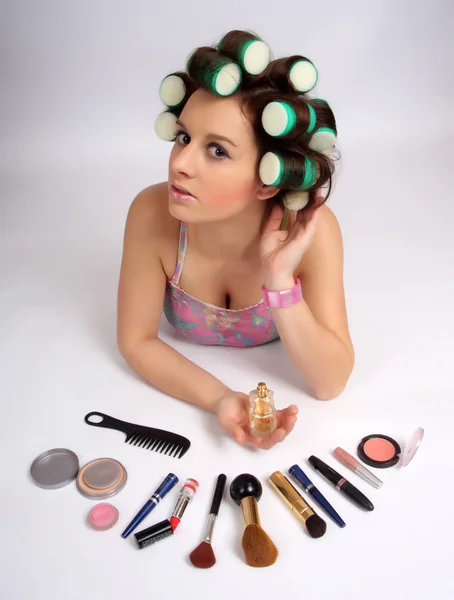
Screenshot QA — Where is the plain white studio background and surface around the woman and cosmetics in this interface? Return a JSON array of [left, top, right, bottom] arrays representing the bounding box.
[[0, 0, 454, 600]]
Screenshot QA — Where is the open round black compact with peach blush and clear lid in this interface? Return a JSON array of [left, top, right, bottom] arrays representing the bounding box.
[[357, 427, 424, 469]]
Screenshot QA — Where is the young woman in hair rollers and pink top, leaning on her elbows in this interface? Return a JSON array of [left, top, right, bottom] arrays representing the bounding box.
[[118, 31, 354, 448]]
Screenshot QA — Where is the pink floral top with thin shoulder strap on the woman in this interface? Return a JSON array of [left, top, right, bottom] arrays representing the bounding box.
[[163, 222, 279, 347]]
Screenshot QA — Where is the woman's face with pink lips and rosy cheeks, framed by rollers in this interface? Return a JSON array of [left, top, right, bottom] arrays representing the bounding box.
[[169, 89, 264, 222]]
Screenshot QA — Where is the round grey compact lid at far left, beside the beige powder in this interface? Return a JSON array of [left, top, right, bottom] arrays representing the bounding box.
[[30, 448, 79, 490]]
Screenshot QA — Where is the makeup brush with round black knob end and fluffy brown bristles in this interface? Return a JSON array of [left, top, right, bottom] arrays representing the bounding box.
[[230, 473, 278, 567]]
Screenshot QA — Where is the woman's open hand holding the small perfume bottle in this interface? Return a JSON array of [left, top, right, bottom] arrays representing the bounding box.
[[216, 391, 298, 450]]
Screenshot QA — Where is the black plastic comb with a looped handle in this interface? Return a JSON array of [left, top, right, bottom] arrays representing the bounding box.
[[85, 411, 191, 458]]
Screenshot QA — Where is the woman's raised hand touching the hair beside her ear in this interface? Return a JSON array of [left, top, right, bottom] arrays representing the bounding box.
[[260, 197, 323, 287]]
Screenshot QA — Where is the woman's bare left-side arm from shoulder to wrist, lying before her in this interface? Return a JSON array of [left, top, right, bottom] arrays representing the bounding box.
[[117, 190, 230, 412]]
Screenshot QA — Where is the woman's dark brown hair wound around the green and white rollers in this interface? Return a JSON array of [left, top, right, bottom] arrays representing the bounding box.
[[160, 30, 337, 227]]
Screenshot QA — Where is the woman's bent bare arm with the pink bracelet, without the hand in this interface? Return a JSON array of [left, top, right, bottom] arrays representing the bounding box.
[[265, 207, 354, 400]]
